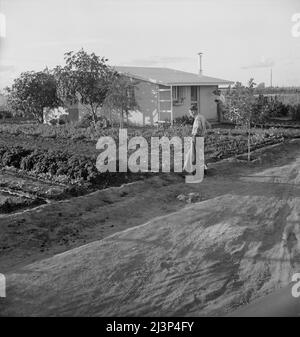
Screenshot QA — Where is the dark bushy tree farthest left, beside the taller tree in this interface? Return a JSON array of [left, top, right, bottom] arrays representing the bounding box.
[[6, 69, 61, 123]]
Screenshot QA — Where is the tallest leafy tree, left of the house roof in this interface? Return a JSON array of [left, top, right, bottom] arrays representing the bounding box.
[[54, 49, 117, 124]]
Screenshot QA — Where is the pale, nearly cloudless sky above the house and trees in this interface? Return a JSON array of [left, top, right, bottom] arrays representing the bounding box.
[[0, 0, 300, 90]]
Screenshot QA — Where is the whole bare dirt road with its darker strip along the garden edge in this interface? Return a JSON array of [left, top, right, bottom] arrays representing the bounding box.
[[0, 142, 300, 316]]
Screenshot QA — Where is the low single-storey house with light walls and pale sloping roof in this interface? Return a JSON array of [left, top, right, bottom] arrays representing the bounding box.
[[115, 67, 233, 125]]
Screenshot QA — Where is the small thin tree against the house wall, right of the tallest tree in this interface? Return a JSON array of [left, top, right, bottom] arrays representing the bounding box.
[[104, 74, 138, 128]]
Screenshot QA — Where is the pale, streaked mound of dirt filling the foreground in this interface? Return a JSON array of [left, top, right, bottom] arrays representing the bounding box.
[[0, 190, 300, 316]]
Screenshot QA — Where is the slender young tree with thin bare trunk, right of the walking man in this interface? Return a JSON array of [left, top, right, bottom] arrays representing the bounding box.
[[225, 78, 257, 161]]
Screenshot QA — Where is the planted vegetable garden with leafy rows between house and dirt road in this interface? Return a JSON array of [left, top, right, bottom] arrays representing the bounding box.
[[0, 126, 300, 212]]
